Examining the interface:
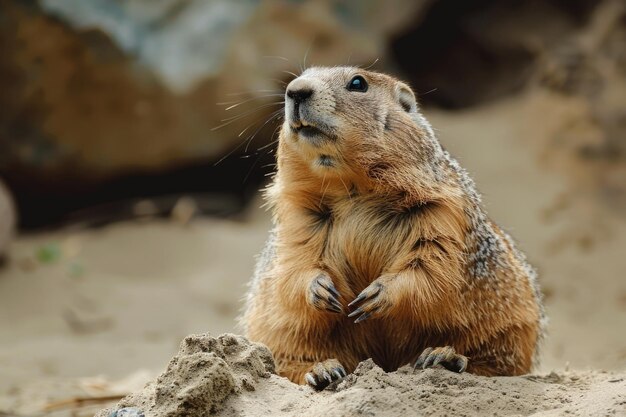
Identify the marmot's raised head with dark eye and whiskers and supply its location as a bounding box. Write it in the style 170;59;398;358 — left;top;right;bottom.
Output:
280;67;441;187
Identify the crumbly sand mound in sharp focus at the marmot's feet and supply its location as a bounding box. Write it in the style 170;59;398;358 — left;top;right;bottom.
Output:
96;334;626;417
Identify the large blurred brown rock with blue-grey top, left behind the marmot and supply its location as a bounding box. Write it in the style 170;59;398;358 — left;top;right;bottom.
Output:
0;0;430;182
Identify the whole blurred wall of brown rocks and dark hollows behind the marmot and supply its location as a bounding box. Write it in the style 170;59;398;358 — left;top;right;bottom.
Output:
0;0;626;226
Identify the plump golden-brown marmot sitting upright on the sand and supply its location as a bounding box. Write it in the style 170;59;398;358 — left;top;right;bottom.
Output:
242;67;545;389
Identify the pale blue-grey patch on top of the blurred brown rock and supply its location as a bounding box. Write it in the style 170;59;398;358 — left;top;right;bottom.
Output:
41;0;258;92
